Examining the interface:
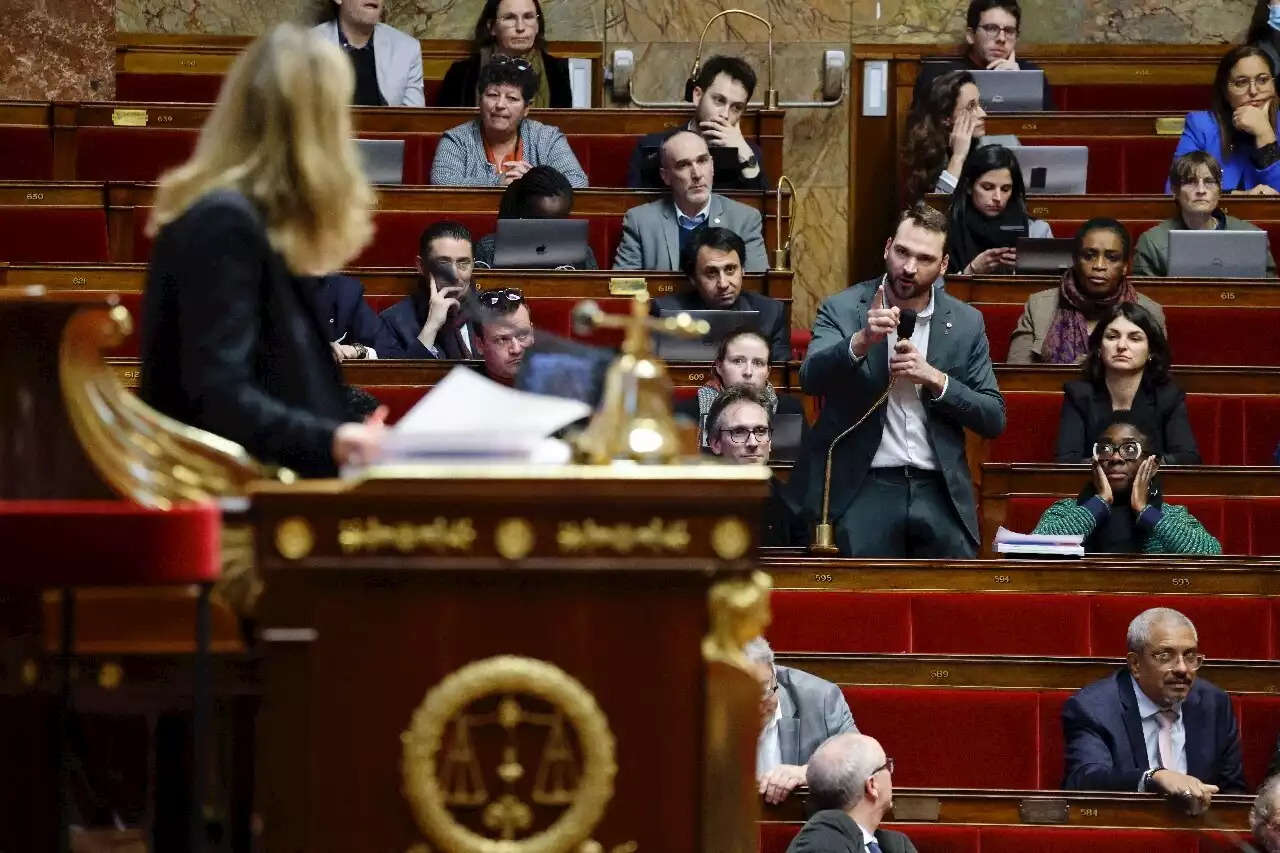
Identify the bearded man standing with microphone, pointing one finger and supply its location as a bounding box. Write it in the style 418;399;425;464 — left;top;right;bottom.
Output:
795;202;1005;558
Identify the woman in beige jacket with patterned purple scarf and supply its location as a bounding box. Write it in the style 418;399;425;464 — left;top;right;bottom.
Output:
1009;216;1165;364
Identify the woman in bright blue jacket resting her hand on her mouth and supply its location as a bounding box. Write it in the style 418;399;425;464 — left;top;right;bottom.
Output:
1165;45;1280;196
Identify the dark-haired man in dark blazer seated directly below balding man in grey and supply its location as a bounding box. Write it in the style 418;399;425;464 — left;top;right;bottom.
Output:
650;228;791;362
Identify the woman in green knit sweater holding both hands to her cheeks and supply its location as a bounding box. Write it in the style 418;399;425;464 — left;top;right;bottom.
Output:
1034;411;1222;555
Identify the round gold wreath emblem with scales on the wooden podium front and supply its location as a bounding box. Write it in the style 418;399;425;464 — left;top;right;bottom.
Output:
401;656;616;853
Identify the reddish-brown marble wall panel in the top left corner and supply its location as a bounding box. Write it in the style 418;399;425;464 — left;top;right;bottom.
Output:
0;0;115;101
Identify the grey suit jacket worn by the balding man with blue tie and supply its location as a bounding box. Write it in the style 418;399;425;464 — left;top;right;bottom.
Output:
613;193;768;273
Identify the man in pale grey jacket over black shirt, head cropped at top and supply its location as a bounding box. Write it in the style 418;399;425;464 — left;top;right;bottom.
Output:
312;0;426;106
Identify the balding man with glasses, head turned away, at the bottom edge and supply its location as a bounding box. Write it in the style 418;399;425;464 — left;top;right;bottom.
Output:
787;731;915;853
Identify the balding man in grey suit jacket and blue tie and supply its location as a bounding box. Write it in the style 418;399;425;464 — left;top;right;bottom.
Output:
613;131;768;273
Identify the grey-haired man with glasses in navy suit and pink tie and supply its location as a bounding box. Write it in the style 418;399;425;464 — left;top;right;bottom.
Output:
1062;607;1245;813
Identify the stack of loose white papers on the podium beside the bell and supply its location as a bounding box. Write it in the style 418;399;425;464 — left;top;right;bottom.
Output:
381;366;591;461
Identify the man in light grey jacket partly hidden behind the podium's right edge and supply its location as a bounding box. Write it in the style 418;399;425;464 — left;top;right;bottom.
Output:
745;637;858;804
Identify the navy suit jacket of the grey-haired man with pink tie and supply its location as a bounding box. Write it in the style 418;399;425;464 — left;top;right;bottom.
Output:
1062;670;1245;794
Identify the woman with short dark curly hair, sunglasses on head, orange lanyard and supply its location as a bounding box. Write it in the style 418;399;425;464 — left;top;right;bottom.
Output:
431;56;586;187
